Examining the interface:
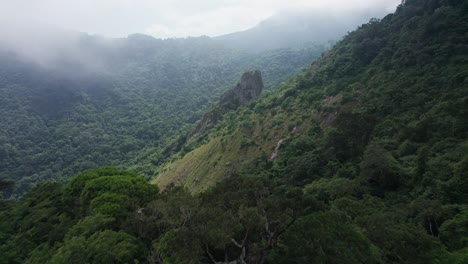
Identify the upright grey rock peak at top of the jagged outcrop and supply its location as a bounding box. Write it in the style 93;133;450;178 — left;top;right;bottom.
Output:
219;71;264;111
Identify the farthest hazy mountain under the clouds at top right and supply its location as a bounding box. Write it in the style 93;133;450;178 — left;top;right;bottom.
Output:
214;8;392;52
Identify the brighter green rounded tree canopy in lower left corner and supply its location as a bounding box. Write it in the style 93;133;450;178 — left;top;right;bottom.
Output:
0;167;158;263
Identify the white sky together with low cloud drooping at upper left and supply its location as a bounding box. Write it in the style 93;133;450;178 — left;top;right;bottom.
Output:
0;0;401;71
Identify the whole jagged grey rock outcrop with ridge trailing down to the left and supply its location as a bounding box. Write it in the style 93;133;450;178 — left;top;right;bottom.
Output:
189;70;264;136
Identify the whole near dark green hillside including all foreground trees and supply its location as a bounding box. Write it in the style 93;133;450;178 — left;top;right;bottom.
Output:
0;0;468;264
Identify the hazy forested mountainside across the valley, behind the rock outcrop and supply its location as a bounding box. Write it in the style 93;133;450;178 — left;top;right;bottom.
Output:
0;35;325;194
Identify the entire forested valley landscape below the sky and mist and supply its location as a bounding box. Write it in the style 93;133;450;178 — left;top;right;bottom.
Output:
0;0;468;264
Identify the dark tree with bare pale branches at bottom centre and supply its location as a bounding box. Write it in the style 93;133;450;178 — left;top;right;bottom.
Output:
154;176;320;263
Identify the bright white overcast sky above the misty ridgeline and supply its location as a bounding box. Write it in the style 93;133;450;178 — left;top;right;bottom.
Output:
0;0;401;38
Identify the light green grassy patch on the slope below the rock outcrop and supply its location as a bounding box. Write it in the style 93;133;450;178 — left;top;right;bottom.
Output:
157;79;318;192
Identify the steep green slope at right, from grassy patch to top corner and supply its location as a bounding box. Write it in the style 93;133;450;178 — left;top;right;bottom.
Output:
156;1;468;196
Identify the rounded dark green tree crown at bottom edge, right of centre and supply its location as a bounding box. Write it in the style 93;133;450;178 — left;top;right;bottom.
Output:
270;212;381;264
